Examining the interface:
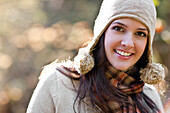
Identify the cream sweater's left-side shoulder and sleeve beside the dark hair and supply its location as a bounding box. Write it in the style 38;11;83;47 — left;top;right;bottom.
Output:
27;62;79;113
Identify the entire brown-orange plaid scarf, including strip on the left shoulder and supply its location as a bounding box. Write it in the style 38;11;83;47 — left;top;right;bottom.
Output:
57;64;157;113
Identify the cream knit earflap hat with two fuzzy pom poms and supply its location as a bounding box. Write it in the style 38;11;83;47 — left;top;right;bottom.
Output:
74;0;165;84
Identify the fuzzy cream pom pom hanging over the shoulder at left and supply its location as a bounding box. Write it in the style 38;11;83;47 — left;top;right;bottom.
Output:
74;48;94;74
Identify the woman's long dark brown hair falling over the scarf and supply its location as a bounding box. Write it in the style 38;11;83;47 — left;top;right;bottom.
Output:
74;35;159;113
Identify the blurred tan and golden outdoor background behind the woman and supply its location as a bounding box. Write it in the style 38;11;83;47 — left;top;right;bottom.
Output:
0;0;170;113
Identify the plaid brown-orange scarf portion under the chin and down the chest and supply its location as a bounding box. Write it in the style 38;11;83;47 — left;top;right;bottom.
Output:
105;65;144;113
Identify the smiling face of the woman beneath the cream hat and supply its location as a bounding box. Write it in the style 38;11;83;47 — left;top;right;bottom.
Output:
104;18;149;71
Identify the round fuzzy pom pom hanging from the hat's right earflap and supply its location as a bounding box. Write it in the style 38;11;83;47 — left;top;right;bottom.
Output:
140;63;165;84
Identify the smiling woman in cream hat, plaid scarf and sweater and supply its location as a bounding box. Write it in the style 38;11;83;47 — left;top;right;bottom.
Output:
27;0;164;113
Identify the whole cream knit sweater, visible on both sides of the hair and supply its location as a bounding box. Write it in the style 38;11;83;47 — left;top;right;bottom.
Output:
26;64;163;113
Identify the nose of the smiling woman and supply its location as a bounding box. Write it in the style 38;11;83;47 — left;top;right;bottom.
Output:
121;33;134;48
